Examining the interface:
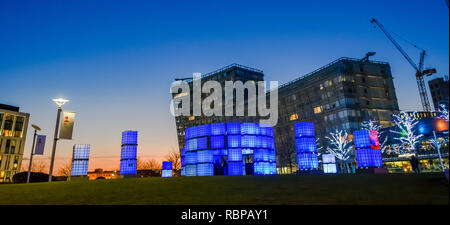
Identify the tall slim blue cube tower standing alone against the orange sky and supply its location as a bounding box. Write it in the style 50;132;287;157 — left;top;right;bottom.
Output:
120;130;138;174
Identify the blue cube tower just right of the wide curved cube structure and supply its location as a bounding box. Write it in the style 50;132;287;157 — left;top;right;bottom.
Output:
294;122;319;170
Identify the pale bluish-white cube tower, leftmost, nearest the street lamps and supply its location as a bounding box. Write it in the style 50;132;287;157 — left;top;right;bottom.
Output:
70;144;91;176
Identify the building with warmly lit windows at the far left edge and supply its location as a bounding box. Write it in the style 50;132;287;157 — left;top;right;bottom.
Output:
0;104;30;182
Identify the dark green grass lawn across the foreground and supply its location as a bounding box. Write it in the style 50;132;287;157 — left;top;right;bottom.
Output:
0;174;449;205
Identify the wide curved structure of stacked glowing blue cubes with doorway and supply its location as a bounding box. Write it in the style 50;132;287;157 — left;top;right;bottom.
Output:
182;122;276;176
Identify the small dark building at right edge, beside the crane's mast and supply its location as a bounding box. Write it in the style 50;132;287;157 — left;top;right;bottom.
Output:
428;77;449;111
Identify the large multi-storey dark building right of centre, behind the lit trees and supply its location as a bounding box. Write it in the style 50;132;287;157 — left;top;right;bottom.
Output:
274;58;399;172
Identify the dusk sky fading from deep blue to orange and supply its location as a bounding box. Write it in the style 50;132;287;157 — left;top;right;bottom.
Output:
0;0;449;169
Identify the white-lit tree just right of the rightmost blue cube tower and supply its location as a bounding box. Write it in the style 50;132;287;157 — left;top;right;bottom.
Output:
391;112;423;154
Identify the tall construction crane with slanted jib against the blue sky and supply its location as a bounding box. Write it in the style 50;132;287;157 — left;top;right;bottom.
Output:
370;19;436;112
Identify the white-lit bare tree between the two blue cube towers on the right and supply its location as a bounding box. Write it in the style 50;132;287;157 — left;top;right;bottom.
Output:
325;129;353;173
